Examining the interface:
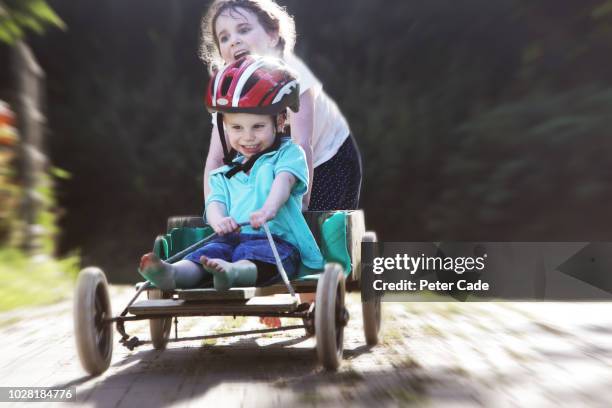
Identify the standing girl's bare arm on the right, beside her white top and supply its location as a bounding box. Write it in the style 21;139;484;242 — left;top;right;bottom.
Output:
288;88;314;210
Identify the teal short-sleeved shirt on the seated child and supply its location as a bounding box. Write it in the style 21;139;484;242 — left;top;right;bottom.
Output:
206;138;324;269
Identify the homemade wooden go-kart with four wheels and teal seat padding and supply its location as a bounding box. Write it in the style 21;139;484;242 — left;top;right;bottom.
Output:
74;210;381;375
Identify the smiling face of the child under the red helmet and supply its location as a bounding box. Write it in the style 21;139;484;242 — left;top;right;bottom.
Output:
223;113;276;159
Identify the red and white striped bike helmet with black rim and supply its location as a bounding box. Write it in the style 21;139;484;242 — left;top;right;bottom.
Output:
206;55;300;115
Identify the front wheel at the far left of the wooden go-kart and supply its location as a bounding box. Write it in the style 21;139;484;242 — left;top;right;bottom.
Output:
74;267;113;375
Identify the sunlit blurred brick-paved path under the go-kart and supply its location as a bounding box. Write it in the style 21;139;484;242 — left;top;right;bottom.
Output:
0;287;612;408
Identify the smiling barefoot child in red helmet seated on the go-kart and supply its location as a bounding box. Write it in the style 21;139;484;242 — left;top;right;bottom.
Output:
139;56;323;290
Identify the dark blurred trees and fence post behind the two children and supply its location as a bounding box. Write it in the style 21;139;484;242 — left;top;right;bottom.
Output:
0;0;612;283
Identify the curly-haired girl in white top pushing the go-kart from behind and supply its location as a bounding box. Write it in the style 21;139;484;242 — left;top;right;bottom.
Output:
201;0;361;211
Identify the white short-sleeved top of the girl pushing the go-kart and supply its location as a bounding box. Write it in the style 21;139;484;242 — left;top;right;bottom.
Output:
212;53;350;167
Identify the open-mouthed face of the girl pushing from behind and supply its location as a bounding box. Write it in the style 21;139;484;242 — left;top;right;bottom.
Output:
215;7;278;64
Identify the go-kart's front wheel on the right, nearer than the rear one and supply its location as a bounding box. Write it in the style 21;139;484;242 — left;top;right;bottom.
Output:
315;263;348;370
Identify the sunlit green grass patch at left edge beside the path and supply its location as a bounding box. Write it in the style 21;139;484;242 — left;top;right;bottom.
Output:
0;248;79;312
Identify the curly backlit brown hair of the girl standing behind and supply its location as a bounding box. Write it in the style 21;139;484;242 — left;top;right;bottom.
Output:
200;0;295;70
